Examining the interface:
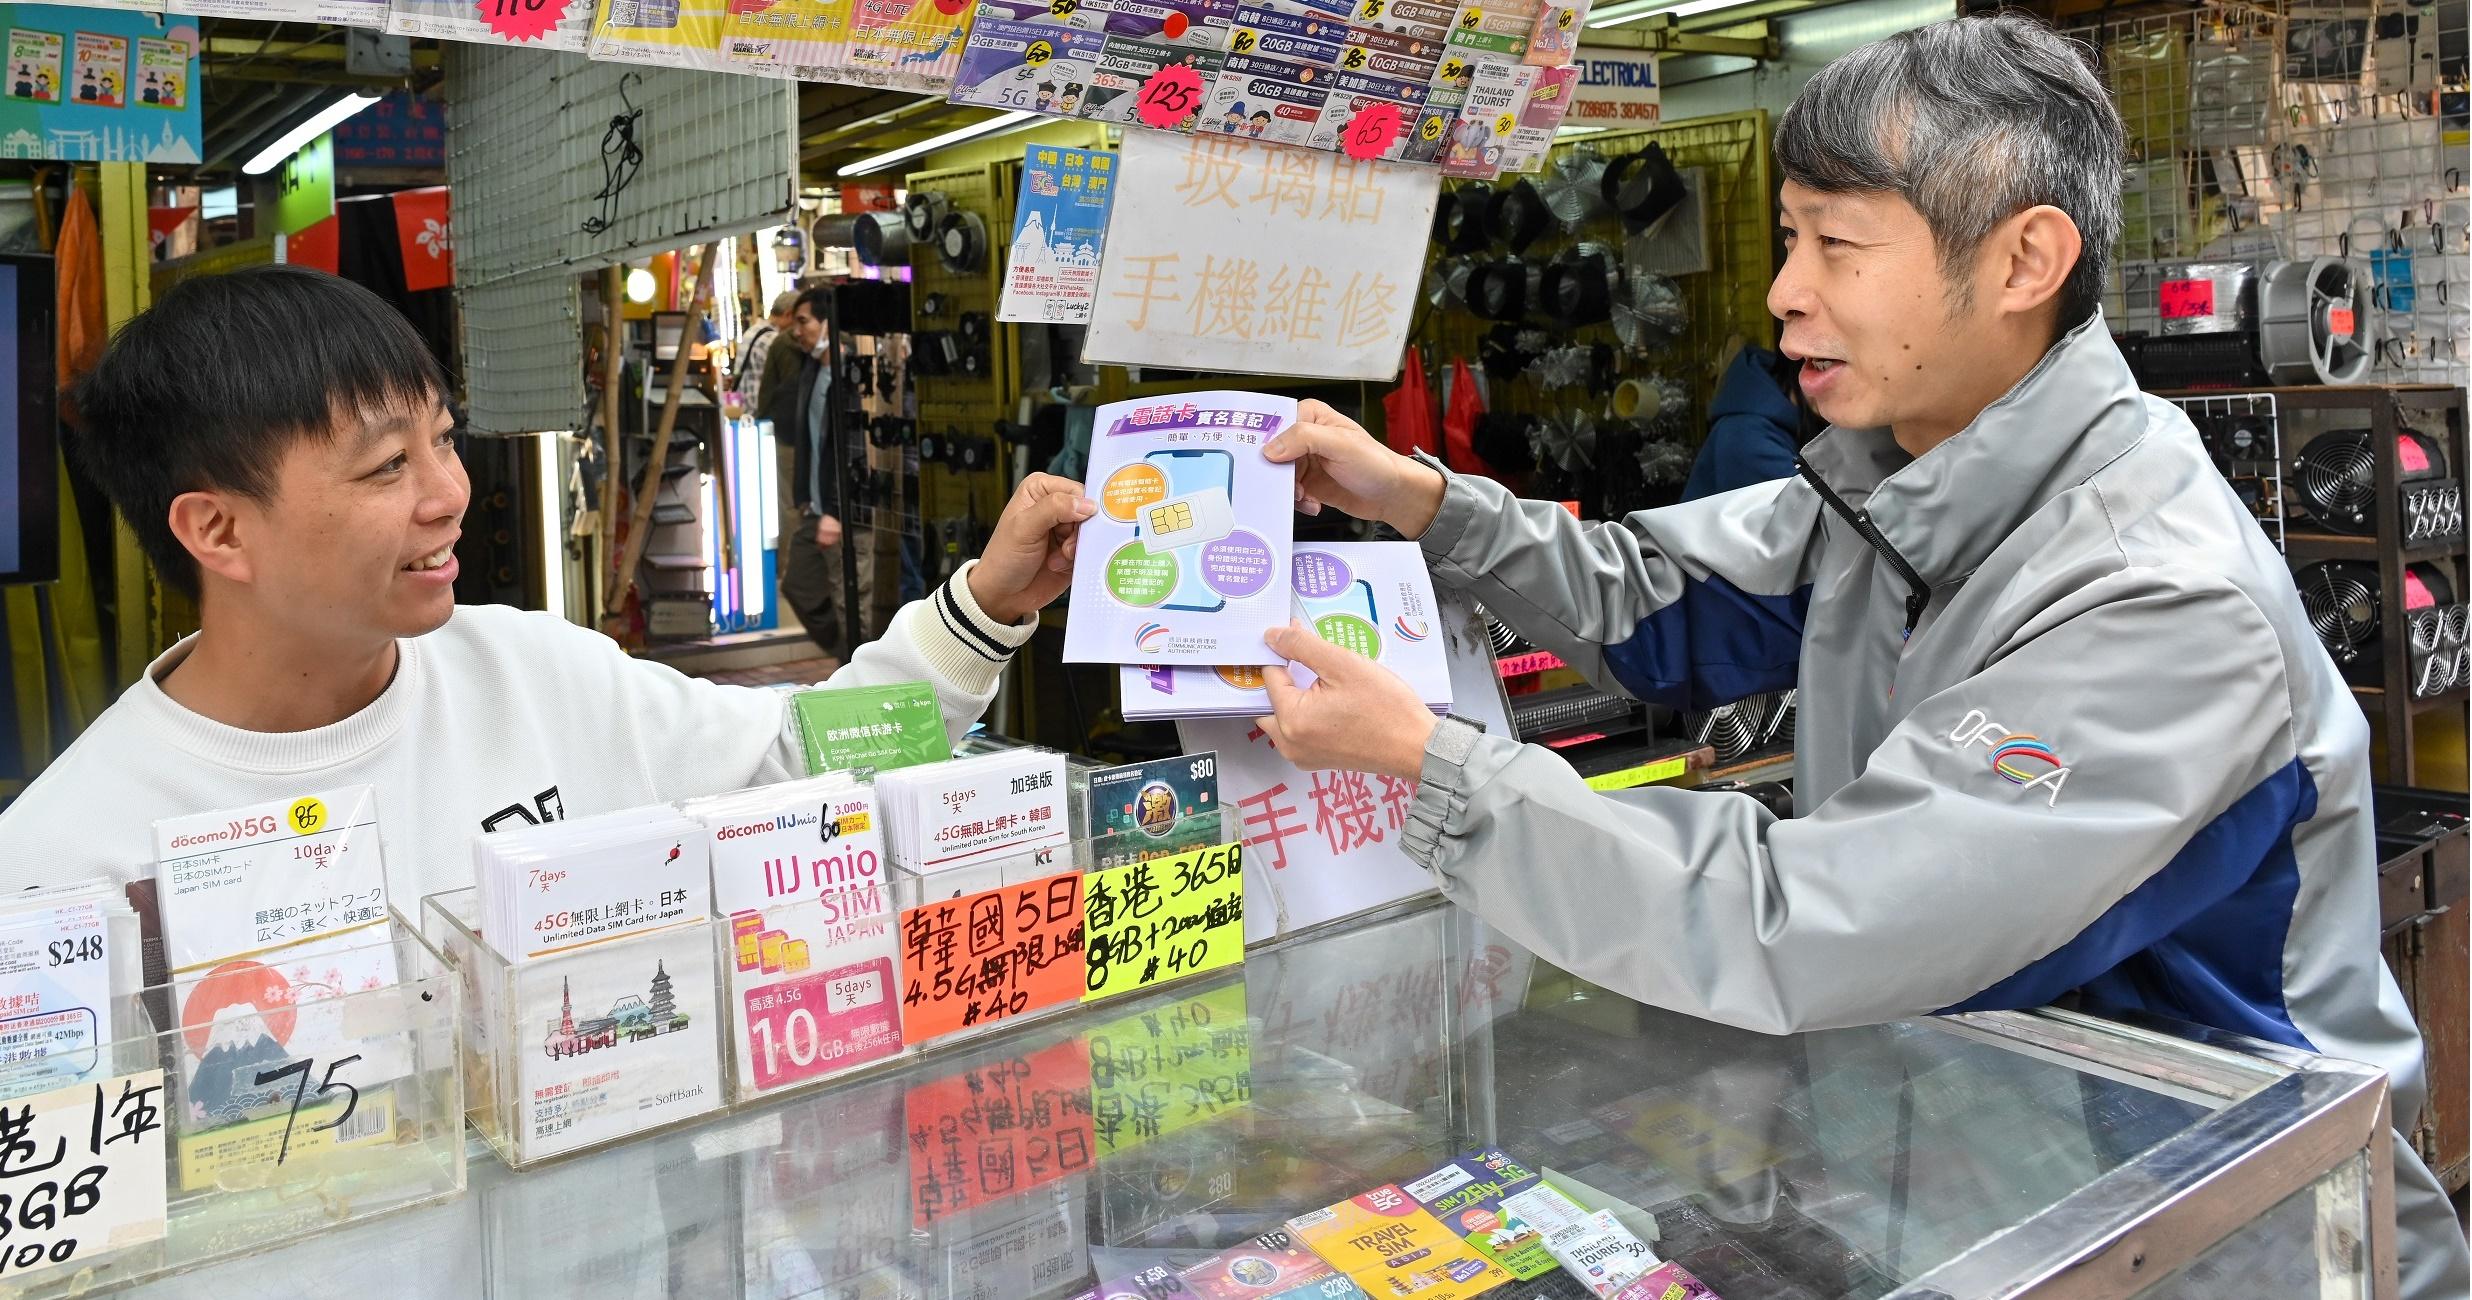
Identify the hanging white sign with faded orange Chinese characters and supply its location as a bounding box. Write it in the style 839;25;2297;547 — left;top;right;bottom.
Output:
1083;131;1441;381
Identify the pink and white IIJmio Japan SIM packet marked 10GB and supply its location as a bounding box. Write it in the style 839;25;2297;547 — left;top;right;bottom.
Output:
680;774;902;1092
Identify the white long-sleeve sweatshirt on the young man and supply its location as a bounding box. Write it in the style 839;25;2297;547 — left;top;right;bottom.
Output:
0;568;1036;919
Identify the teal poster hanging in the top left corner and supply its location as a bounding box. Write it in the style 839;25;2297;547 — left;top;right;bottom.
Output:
0;5;200;163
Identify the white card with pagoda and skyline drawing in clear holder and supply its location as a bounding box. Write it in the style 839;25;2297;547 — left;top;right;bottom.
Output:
509;927;722;1159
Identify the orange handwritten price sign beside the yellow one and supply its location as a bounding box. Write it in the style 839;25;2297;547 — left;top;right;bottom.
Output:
900;872;1083;1043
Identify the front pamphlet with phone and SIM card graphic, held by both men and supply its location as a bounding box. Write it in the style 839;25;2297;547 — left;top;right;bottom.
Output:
1065;393;1295;665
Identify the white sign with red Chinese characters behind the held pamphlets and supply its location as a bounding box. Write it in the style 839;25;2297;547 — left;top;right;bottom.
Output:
1177;591;1513;944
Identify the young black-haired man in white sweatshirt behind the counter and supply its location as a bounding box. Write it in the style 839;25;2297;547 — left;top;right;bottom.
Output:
0;267;1093;914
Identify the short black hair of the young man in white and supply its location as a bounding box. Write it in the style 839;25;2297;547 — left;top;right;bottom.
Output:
69;267;452;596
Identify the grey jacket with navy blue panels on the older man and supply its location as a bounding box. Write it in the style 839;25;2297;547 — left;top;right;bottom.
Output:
1409;316;2467;1300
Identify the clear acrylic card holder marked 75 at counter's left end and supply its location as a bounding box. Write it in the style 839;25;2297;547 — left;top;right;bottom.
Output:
0;917;465;1300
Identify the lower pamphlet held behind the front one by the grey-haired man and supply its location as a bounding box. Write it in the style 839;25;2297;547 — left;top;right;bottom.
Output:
1120;541;1451;722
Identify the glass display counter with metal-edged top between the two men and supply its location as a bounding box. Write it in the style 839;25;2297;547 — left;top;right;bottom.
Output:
131;902;2393;1300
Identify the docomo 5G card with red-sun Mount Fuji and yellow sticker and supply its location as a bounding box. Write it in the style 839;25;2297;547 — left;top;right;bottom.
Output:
153;786;410;1166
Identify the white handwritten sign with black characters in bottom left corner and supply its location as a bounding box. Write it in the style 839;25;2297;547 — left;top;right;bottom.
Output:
0;1070;166;1288
